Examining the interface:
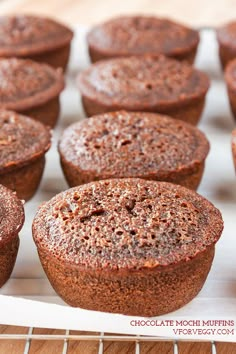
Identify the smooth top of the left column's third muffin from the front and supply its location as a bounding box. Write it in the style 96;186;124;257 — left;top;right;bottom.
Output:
0;58;64;111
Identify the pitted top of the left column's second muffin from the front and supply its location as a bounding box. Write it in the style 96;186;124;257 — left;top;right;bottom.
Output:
0;110;51;174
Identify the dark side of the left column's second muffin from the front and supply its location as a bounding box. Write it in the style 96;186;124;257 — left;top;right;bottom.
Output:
0;155;45;201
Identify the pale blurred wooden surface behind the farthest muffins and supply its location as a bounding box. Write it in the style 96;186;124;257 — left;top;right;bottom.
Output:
0;0;236;26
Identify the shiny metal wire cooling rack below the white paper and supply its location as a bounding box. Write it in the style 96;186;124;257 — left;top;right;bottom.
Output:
0;327;217;354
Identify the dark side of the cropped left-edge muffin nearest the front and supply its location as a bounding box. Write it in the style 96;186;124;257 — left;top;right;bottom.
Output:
0;235;20;288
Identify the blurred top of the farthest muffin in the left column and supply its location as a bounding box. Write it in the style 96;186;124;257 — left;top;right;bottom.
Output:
0;15;73;57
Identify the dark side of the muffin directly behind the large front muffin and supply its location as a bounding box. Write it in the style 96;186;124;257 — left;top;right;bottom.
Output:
60;156;205;190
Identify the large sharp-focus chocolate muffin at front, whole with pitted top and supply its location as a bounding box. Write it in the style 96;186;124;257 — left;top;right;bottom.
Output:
33;178;223;316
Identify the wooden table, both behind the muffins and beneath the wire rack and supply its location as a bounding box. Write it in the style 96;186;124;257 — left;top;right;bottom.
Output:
0;0;236;354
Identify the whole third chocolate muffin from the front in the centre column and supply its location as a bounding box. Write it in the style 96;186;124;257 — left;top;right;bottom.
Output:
78;56;209;124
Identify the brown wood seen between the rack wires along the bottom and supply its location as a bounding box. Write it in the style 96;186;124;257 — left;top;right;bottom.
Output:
0;325;236;354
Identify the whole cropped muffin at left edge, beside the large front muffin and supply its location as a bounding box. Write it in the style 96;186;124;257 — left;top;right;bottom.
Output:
0;185;25;287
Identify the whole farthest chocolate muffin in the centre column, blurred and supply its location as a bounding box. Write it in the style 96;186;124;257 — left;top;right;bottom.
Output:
87;16;199;63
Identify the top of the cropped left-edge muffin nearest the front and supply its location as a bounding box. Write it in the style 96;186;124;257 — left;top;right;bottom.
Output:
0;184;25;246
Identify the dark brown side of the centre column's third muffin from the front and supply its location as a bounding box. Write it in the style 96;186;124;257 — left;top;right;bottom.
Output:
82;96;205;125
